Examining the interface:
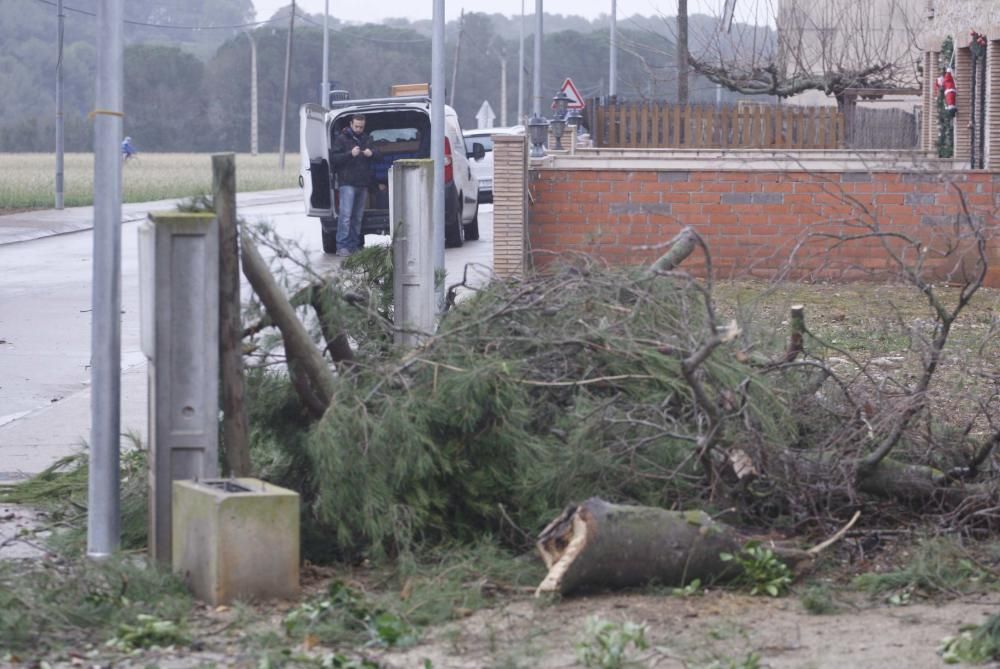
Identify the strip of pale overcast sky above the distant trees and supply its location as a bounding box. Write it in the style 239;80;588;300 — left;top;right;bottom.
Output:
254;0;770;29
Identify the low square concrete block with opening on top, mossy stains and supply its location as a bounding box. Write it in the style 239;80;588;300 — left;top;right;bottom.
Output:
171;478;299;606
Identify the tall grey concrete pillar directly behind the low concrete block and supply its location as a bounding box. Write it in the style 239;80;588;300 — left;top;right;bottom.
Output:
139;212;219;562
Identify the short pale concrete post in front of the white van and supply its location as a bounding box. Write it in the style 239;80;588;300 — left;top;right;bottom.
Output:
389;160;437;347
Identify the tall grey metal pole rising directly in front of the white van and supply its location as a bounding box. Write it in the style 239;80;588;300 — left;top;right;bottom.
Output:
431;0;446;310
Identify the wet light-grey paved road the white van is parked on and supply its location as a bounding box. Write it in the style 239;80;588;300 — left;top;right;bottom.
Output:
0;189;493;481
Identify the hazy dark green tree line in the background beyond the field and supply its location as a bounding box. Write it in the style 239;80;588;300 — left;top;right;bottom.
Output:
0;0;736;152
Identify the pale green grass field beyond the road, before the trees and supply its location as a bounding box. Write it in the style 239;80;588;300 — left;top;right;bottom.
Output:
0;153;299;211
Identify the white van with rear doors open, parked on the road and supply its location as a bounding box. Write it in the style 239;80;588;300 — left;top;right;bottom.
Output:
299;95;485;253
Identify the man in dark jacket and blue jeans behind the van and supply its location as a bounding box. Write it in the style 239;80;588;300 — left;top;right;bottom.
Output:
331;114;375;256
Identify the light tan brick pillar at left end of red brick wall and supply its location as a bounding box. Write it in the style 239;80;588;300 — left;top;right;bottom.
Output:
493;135;528;278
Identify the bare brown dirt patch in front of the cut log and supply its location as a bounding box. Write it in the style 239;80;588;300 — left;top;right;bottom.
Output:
381;592;1000;669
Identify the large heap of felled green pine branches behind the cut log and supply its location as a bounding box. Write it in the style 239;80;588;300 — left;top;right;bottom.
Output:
292;260;792;556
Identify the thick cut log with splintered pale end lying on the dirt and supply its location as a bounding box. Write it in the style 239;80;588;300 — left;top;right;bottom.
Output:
535;497;743;595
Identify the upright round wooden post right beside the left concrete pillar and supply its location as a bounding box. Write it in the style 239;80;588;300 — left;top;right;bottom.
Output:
212;153;251;476
